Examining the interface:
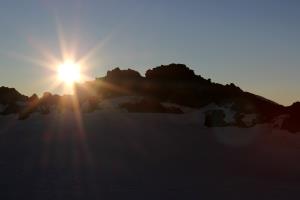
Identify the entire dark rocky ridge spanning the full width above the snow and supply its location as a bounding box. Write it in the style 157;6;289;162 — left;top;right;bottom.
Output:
0;63;300;132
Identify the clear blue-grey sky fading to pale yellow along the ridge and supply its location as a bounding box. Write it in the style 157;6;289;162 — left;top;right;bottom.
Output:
0;0;300;105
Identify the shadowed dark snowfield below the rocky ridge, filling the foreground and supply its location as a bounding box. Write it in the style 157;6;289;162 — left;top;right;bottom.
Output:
0;97;300;200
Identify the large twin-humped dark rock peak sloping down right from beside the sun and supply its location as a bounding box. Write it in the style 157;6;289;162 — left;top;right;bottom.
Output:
86;63;284;118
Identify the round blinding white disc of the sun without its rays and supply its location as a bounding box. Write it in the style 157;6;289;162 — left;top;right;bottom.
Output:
57;60;81;85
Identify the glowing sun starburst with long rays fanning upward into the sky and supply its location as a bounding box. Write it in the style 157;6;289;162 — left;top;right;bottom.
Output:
10;12;117;97
